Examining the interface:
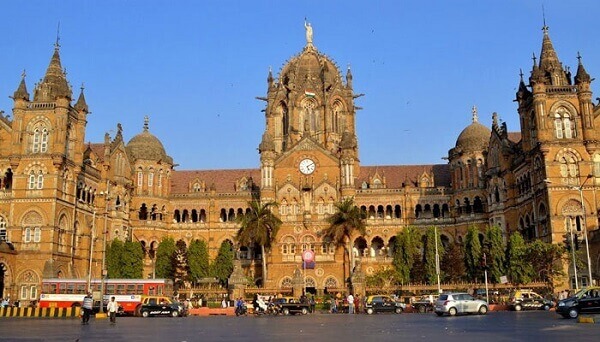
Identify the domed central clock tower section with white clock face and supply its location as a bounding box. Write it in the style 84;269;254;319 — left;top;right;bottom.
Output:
259;26;359;286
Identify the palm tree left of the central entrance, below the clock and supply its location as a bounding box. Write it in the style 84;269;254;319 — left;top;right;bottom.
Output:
236;200;281;287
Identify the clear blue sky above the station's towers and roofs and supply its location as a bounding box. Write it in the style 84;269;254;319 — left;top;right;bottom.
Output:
0;0;600;170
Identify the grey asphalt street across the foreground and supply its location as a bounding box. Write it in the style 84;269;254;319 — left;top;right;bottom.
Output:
0;311;600;342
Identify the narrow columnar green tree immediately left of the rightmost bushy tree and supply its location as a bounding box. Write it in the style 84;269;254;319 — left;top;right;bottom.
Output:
506;232;533;285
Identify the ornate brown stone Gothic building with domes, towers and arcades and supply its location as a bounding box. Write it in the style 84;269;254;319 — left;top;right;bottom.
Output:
0;27;600;301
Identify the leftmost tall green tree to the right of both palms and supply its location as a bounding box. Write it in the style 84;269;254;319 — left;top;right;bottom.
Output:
392;227;421;283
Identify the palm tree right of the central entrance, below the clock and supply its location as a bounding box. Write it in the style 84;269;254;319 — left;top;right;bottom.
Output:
322;197;367;288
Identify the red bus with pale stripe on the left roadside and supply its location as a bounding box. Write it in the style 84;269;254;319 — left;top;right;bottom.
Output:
39;278;173;315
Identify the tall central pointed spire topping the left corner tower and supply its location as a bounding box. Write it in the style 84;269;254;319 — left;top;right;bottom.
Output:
34;43;73;102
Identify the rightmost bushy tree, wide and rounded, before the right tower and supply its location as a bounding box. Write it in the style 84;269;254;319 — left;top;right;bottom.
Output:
526;240;566;284
